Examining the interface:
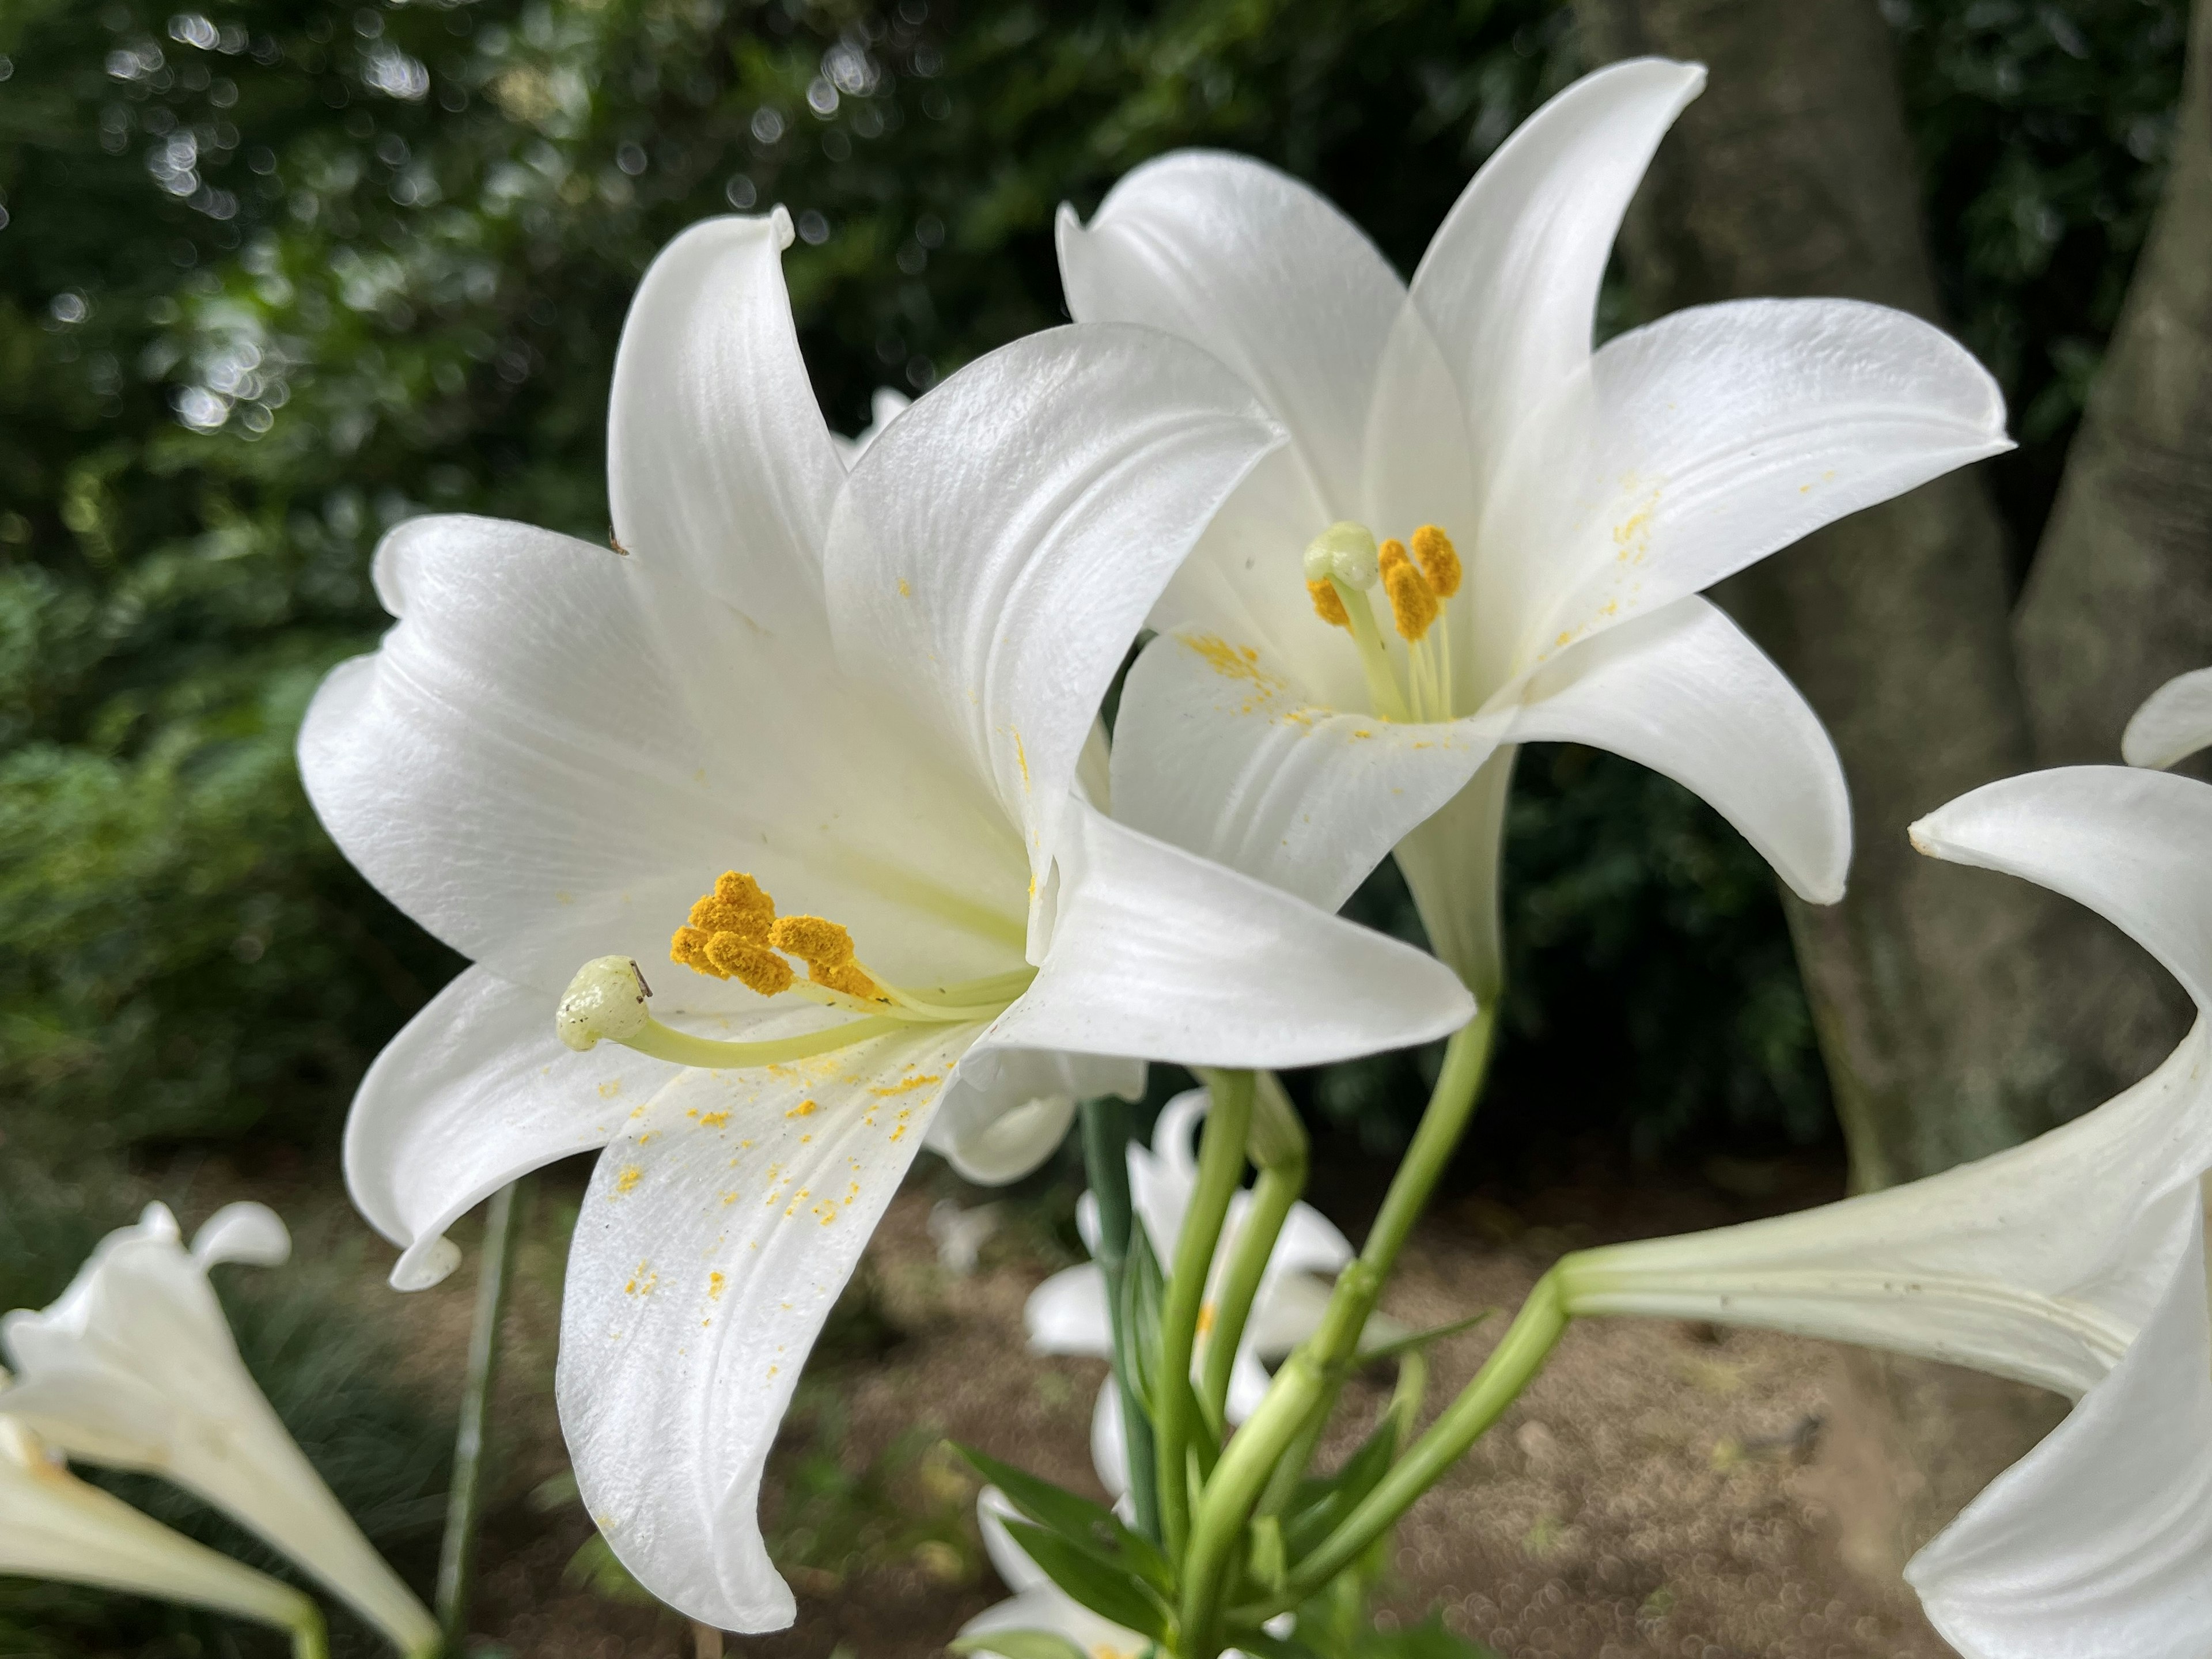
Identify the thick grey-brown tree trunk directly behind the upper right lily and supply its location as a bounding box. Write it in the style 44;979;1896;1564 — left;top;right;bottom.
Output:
1577;0;2179;1584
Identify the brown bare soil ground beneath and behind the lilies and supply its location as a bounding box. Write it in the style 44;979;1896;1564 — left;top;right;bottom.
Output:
188;1166;1949;1659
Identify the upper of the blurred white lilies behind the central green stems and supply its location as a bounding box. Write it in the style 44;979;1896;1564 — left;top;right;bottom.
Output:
1022;1088;1351;1442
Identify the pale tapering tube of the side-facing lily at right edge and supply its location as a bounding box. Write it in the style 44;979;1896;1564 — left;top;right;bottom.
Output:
1569;1026;2212;1396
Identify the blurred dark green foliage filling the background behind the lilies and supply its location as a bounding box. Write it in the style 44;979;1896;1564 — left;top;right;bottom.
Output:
0;0;2179;1157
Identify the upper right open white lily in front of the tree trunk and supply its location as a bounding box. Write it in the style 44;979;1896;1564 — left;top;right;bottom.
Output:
1059;60;2009;995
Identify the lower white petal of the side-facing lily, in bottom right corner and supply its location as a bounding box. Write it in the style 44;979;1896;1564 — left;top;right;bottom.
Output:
1904;1192;2212;1659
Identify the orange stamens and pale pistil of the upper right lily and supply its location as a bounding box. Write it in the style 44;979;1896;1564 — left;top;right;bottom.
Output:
1305;520;1460;724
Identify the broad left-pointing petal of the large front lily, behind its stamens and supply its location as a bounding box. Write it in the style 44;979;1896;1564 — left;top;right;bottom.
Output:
298;518;1027;1011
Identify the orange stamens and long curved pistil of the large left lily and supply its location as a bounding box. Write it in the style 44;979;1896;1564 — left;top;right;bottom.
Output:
553;869;1037;1071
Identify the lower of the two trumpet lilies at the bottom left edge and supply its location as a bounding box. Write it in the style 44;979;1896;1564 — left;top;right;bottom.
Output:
0;1415;321;1652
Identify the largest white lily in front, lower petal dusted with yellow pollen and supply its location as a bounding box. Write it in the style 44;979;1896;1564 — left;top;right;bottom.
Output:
301;210;1471;1630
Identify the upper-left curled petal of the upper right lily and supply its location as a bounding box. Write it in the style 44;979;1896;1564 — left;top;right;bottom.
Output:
1055;150;1404;533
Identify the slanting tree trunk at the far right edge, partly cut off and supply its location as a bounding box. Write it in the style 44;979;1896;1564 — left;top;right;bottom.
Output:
2015;0;2212;766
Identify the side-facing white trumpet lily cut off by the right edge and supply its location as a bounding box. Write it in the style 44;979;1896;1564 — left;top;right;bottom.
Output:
1562;767;2212;1659
